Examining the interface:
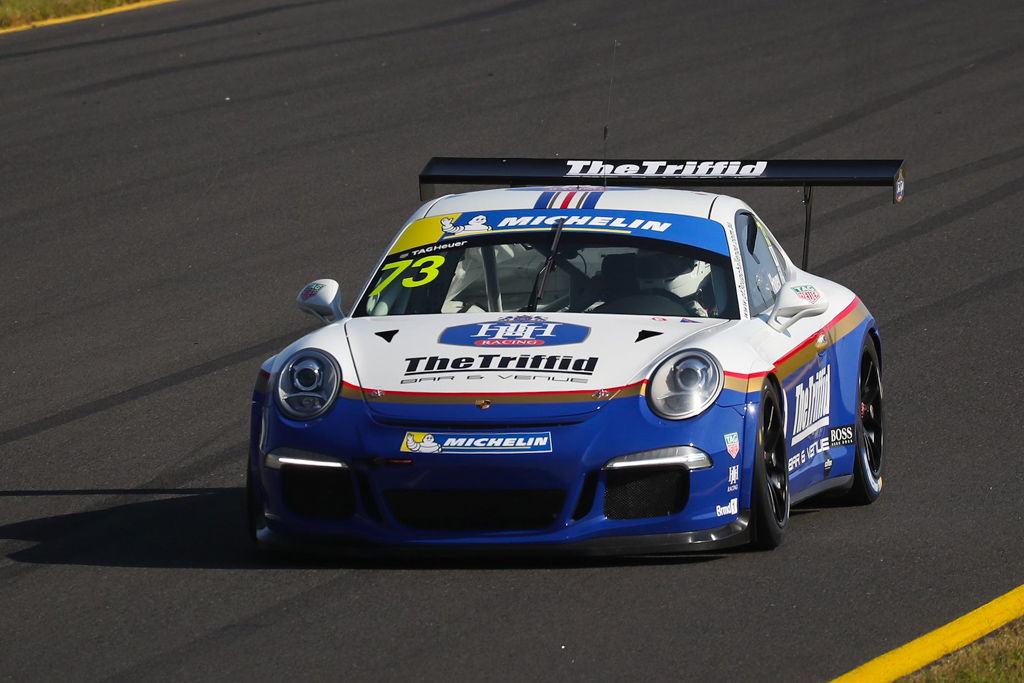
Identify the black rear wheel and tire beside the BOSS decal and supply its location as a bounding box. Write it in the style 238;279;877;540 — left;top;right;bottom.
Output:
847;337;885;505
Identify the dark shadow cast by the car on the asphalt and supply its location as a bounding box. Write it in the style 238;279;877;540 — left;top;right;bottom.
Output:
0;487;730;570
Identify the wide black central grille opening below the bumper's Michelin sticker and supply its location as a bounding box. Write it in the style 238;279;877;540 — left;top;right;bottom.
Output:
384;488;565;531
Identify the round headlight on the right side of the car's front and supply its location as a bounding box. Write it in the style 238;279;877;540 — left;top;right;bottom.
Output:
647;349;723;420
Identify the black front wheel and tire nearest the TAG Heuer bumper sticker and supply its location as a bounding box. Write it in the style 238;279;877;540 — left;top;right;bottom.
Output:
751;380;790;550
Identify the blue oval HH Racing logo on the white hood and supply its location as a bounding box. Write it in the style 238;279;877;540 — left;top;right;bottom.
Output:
437;315;590;346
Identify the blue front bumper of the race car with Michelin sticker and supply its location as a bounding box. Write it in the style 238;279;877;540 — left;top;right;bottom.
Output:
250;387;756;555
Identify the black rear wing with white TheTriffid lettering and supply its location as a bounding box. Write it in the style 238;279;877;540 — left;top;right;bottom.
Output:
420;157;905;268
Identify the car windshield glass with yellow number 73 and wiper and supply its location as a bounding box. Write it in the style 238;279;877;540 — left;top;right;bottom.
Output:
355;230;739;318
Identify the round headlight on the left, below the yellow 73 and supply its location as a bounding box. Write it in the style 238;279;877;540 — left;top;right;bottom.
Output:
278;348;341;420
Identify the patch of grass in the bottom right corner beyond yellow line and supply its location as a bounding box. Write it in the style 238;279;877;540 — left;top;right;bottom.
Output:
900;618;1024;683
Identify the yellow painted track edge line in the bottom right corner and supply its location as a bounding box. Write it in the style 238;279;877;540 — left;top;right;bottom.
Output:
833;586;1024;683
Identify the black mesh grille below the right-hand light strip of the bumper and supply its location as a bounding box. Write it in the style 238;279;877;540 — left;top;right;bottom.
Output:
604;468;690;519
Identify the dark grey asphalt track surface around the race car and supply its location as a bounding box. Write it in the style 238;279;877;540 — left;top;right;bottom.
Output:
0;0;1024;681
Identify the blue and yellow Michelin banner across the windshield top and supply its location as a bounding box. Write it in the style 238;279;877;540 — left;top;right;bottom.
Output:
389;209;729;256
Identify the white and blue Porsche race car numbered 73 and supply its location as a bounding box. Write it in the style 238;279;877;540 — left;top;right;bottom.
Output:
247;158;903;554
